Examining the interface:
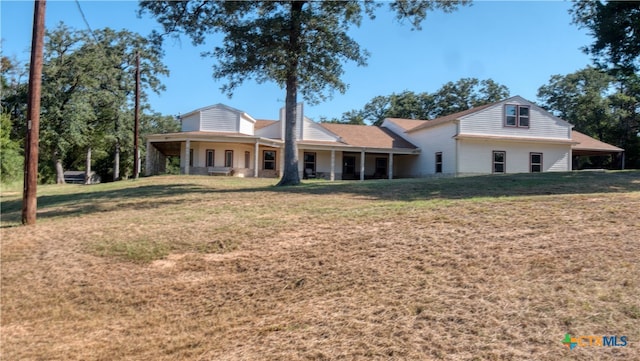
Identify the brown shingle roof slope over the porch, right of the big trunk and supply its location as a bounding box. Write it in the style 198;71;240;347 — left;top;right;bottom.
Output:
320;123;417;149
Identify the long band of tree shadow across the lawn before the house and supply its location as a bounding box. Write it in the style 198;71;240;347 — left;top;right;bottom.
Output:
2;171;640;227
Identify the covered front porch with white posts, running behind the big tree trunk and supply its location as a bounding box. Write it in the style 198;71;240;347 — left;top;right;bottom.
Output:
145;132;420;181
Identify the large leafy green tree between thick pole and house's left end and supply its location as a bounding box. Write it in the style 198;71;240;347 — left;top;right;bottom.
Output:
41;24;168;182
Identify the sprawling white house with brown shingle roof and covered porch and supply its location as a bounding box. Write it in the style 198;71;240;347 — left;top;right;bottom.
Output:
145;96;623;180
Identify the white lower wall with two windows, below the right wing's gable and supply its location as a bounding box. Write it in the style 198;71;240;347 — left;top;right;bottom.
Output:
458;139;571;176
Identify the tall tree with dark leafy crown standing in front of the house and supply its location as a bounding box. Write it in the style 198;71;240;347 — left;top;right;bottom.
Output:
140;0;468;185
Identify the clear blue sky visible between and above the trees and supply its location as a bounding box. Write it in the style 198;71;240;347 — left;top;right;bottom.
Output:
0;0;592;119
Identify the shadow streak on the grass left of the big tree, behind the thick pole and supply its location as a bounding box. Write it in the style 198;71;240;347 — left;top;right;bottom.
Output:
2;184;210;228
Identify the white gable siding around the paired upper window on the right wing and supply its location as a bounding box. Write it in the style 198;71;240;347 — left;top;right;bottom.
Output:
460;97;571;139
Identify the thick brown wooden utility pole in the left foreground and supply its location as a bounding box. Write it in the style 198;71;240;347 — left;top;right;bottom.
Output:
22;0;46;225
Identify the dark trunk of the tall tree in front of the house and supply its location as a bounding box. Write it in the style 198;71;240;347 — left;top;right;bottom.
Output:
277;1;305;186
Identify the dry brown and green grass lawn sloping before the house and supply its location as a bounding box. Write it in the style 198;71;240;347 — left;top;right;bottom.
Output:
0;172;640;360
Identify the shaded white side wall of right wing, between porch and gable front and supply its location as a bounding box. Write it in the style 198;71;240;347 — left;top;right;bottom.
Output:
398;122;457;177
